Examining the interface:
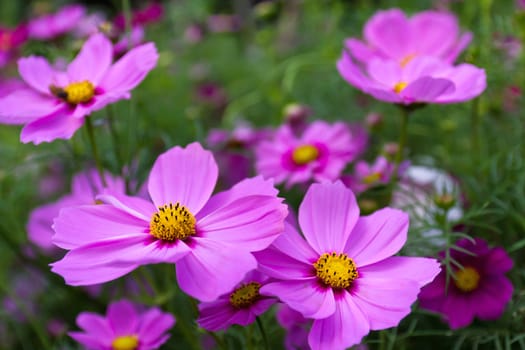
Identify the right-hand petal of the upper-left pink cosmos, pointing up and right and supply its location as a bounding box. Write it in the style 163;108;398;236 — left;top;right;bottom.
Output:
100;43;159;94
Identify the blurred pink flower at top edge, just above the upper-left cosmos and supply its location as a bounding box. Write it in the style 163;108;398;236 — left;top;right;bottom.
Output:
28;4;86;40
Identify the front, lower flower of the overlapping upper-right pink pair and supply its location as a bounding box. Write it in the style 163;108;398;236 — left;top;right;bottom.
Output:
337;52;487;105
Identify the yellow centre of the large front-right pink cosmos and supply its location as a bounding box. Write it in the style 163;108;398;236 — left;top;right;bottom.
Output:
314;253;359;289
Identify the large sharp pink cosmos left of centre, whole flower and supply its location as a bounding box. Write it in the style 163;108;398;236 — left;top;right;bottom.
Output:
52;143;287;301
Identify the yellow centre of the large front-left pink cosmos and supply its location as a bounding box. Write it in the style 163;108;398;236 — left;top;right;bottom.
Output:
149;202;196;242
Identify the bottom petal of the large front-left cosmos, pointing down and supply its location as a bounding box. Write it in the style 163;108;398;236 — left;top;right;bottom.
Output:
176;238;257;301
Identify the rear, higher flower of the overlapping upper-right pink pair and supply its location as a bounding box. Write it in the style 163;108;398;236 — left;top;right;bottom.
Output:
345;9;472;66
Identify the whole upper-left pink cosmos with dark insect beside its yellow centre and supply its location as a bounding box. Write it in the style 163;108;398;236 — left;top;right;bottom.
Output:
0;33;158;144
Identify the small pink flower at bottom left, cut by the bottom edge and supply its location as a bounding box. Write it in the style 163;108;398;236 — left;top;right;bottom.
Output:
68;300;175;350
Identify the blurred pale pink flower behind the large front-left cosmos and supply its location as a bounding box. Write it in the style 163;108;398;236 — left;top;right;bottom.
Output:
27;170;126;253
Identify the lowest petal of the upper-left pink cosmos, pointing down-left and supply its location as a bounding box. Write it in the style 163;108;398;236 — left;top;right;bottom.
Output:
20;109;84;145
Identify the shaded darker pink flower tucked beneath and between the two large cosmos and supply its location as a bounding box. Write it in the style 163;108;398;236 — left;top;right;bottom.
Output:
197;270;277;332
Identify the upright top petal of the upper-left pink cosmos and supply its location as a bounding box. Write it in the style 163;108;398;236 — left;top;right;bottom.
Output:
67;33;113;87
